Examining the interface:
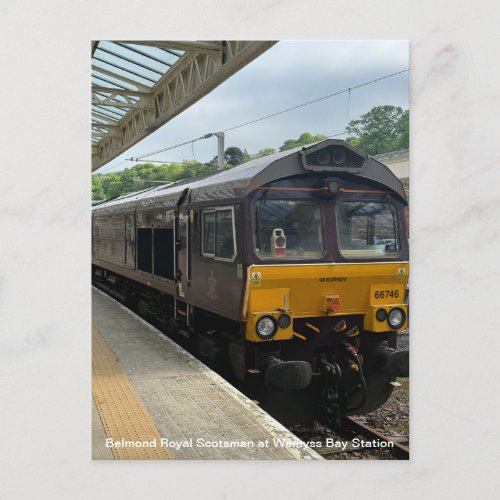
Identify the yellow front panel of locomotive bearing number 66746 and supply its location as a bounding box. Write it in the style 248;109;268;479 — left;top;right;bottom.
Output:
243;262;408;342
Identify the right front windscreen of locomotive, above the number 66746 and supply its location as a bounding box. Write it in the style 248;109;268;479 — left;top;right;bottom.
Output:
337;201;400;259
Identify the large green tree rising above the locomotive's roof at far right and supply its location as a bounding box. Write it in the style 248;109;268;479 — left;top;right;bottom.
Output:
346;105;409;155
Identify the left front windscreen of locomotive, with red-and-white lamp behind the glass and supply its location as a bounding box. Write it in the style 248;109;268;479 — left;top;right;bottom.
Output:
254;200;324;259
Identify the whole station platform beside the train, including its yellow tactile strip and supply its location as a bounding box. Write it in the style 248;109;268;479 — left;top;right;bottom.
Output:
92;288;322;460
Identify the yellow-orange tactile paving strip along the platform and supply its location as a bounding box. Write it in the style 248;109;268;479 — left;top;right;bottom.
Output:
92;328;174;460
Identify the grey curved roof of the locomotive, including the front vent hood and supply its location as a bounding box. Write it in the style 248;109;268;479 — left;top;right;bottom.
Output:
93;139;406;215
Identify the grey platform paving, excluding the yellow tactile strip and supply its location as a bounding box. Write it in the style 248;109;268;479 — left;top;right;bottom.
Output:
92;288;322;460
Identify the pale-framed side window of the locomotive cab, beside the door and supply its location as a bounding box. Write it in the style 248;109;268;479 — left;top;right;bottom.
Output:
202;208;236;260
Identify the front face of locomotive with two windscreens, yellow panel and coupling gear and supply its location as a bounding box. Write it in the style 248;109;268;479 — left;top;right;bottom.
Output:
239;143;409;423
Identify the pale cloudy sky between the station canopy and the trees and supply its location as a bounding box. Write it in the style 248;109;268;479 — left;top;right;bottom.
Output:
96;40;409;173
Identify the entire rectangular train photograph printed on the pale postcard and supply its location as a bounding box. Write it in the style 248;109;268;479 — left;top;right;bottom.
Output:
91;40;410;460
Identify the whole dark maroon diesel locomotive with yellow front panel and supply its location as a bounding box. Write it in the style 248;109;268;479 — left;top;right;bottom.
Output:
92;139;409;426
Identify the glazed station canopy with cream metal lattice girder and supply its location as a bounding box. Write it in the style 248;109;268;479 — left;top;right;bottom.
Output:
92;40;276;171
